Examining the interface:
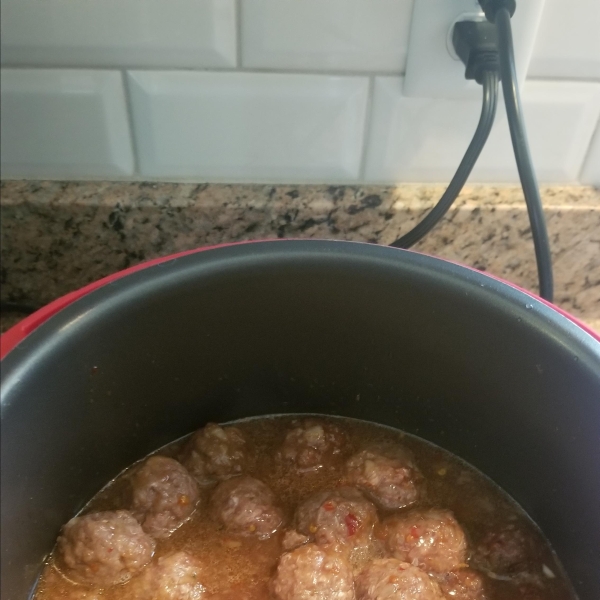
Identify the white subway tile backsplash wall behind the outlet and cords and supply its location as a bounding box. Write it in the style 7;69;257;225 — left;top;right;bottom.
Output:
1;0;600;185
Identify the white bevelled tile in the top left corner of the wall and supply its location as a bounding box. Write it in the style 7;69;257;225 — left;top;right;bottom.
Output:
1;0;236;68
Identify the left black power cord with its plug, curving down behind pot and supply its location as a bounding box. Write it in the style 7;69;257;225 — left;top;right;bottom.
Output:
390;21;499;249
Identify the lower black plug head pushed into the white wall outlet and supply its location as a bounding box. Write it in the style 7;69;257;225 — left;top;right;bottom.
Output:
452;21;500;84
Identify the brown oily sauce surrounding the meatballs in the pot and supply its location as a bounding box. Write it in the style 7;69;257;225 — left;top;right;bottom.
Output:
34;416;575;600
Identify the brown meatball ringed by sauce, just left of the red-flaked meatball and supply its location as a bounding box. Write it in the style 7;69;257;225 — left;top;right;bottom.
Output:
211;476;283;539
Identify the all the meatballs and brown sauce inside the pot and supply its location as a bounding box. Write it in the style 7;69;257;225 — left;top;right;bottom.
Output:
34;417;575;600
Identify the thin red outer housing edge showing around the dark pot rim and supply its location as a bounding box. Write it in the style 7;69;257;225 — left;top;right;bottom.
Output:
0;240;600;360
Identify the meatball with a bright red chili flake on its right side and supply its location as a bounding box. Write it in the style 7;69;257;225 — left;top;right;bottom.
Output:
296;487;377;546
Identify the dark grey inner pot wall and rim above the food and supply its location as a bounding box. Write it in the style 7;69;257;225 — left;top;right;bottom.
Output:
1;241;600;600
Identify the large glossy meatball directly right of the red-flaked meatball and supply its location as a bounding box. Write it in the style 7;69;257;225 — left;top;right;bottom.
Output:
385;509;467;573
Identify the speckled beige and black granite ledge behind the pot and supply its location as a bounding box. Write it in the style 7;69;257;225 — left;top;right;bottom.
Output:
0;181;600;330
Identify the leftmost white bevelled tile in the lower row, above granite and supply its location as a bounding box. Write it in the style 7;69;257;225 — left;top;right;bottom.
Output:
1;69;134;179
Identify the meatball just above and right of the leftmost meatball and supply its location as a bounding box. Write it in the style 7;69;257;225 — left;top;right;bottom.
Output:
131;456;200;539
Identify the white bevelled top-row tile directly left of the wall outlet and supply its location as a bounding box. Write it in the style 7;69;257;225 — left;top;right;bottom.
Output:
241;0;413;73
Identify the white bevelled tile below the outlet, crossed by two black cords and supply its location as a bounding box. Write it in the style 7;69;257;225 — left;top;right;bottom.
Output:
366;77;600;183
